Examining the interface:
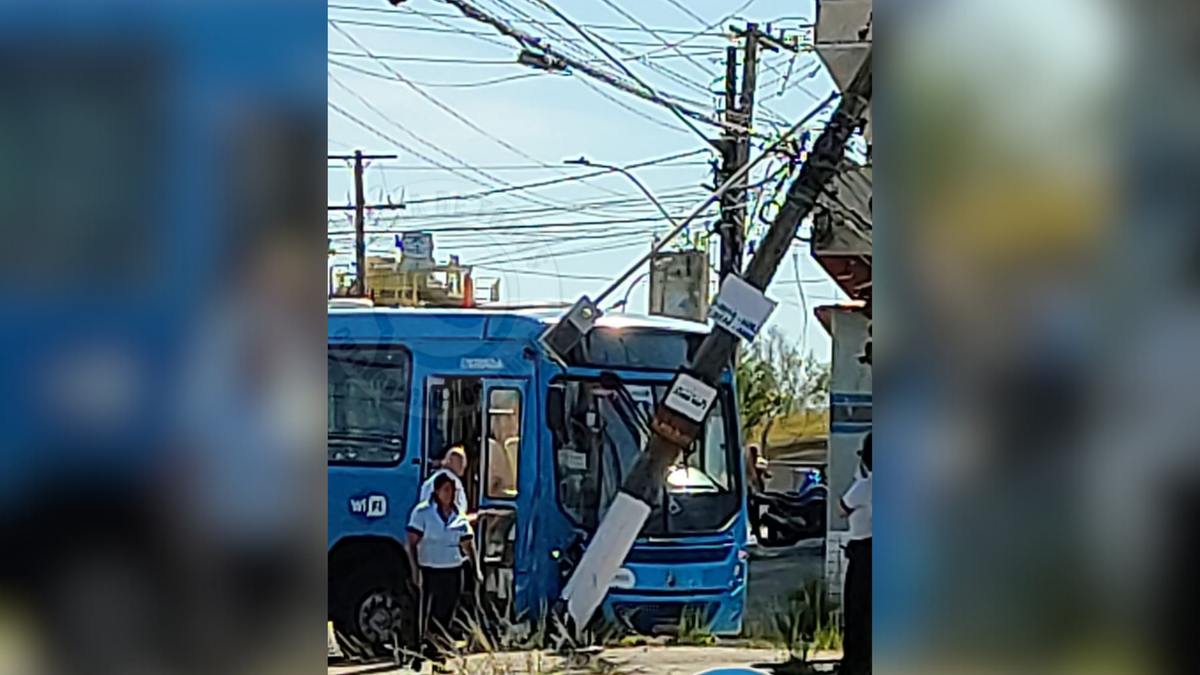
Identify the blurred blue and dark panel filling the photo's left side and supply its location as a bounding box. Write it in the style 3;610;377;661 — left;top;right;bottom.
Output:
0;1;325;675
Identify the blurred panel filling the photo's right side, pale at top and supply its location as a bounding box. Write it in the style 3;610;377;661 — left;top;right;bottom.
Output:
875;0;1200;673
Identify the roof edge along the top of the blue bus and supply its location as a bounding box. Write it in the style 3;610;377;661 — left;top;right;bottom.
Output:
329;304;710;340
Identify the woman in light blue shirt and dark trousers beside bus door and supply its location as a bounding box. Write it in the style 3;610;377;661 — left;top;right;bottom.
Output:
407;473;481;662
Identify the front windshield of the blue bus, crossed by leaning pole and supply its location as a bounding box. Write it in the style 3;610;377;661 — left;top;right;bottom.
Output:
547;374;742;536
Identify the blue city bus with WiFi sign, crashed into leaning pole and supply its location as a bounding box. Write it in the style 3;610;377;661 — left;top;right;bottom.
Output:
328;304;748;644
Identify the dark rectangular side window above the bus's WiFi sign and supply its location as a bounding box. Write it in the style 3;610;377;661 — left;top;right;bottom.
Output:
328;345;413;465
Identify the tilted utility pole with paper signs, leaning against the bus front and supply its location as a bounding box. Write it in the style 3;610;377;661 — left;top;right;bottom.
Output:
562;52;871;628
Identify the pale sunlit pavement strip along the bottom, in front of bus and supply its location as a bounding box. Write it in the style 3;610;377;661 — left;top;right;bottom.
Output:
329;646;838;675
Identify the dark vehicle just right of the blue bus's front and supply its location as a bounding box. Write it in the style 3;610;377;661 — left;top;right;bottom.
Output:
750;470;829;546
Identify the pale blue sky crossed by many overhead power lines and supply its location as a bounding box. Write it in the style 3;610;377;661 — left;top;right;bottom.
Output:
329;0;844;360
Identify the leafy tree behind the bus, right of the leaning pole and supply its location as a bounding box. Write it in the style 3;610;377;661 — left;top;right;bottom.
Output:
734;328;829;448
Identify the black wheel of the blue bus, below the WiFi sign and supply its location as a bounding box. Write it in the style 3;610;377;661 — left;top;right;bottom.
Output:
331;566;416;652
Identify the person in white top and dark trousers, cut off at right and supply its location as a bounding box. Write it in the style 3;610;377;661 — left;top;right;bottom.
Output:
839;432;871;675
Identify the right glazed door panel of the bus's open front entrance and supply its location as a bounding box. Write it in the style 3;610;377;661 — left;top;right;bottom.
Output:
475;378;534;603
